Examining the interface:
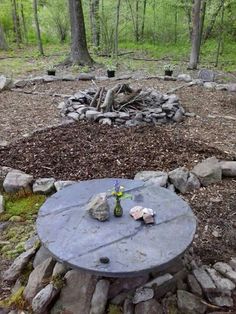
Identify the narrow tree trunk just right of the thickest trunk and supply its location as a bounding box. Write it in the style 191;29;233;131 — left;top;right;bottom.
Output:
89;0;100;47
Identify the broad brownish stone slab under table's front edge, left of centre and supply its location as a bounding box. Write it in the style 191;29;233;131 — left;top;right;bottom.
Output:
51;270;97;314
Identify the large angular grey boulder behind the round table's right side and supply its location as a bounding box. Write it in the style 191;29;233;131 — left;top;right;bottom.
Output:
192;157;222;186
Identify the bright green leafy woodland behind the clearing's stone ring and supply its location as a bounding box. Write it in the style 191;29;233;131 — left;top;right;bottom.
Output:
0;0;236;72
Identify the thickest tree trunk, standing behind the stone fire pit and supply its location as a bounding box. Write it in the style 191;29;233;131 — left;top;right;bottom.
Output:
69;0;93;65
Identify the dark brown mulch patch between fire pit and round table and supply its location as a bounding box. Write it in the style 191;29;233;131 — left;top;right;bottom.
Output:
0;123;230;180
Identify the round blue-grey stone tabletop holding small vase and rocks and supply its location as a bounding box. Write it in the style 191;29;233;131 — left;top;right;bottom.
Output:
37;179;196;277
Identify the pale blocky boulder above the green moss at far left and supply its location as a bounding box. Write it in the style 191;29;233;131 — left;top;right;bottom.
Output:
3;169;33;193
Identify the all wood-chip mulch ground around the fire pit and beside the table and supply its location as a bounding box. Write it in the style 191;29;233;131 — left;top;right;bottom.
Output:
0;63;236;304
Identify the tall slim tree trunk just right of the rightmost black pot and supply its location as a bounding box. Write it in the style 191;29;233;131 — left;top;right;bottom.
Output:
188;0;201;69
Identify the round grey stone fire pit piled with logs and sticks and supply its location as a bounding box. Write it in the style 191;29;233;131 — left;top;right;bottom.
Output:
58;84;185;126
